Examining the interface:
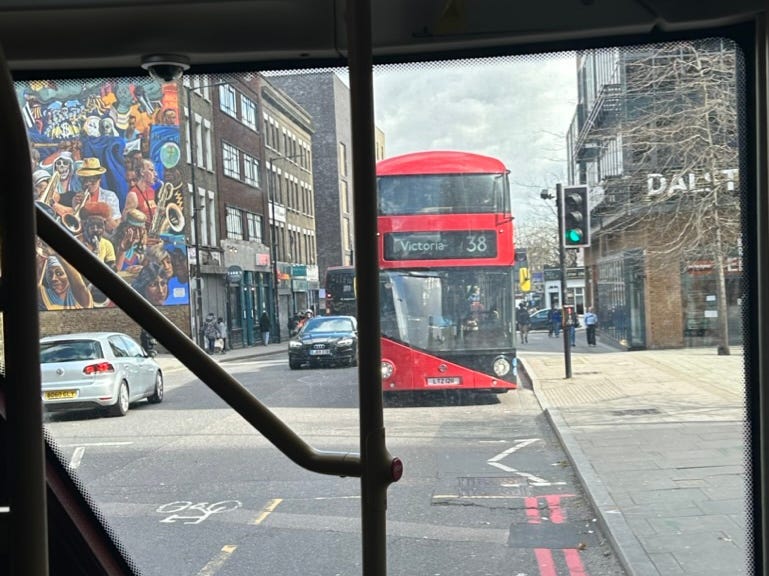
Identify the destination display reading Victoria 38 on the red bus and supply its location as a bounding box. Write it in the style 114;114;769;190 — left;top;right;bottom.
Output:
384;230;497;260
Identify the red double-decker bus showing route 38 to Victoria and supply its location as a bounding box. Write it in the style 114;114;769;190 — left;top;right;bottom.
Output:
377;151;517;392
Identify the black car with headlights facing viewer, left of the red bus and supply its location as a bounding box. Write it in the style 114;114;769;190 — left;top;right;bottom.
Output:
288;316;358;370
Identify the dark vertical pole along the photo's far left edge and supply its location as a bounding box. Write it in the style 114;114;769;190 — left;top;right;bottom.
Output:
0;42;48;576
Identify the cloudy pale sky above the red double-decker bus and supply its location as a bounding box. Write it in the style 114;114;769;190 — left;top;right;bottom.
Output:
374;54;577;218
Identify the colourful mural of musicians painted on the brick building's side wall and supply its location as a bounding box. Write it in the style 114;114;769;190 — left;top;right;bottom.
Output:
16;78;189;310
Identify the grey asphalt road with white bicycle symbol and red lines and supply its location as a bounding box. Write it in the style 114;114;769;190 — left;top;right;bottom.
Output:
47;352;622;576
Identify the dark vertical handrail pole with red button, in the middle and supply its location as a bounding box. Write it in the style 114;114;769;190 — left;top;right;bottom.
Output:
347;0;400;576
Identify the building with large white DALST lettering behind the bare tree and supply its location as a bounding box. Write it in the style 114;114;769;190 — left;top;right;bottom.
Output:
567;41;742;351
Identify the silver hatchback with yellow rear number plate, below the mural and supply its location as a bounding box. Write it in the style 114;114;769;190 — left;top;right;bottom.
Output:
40;332;163;416
